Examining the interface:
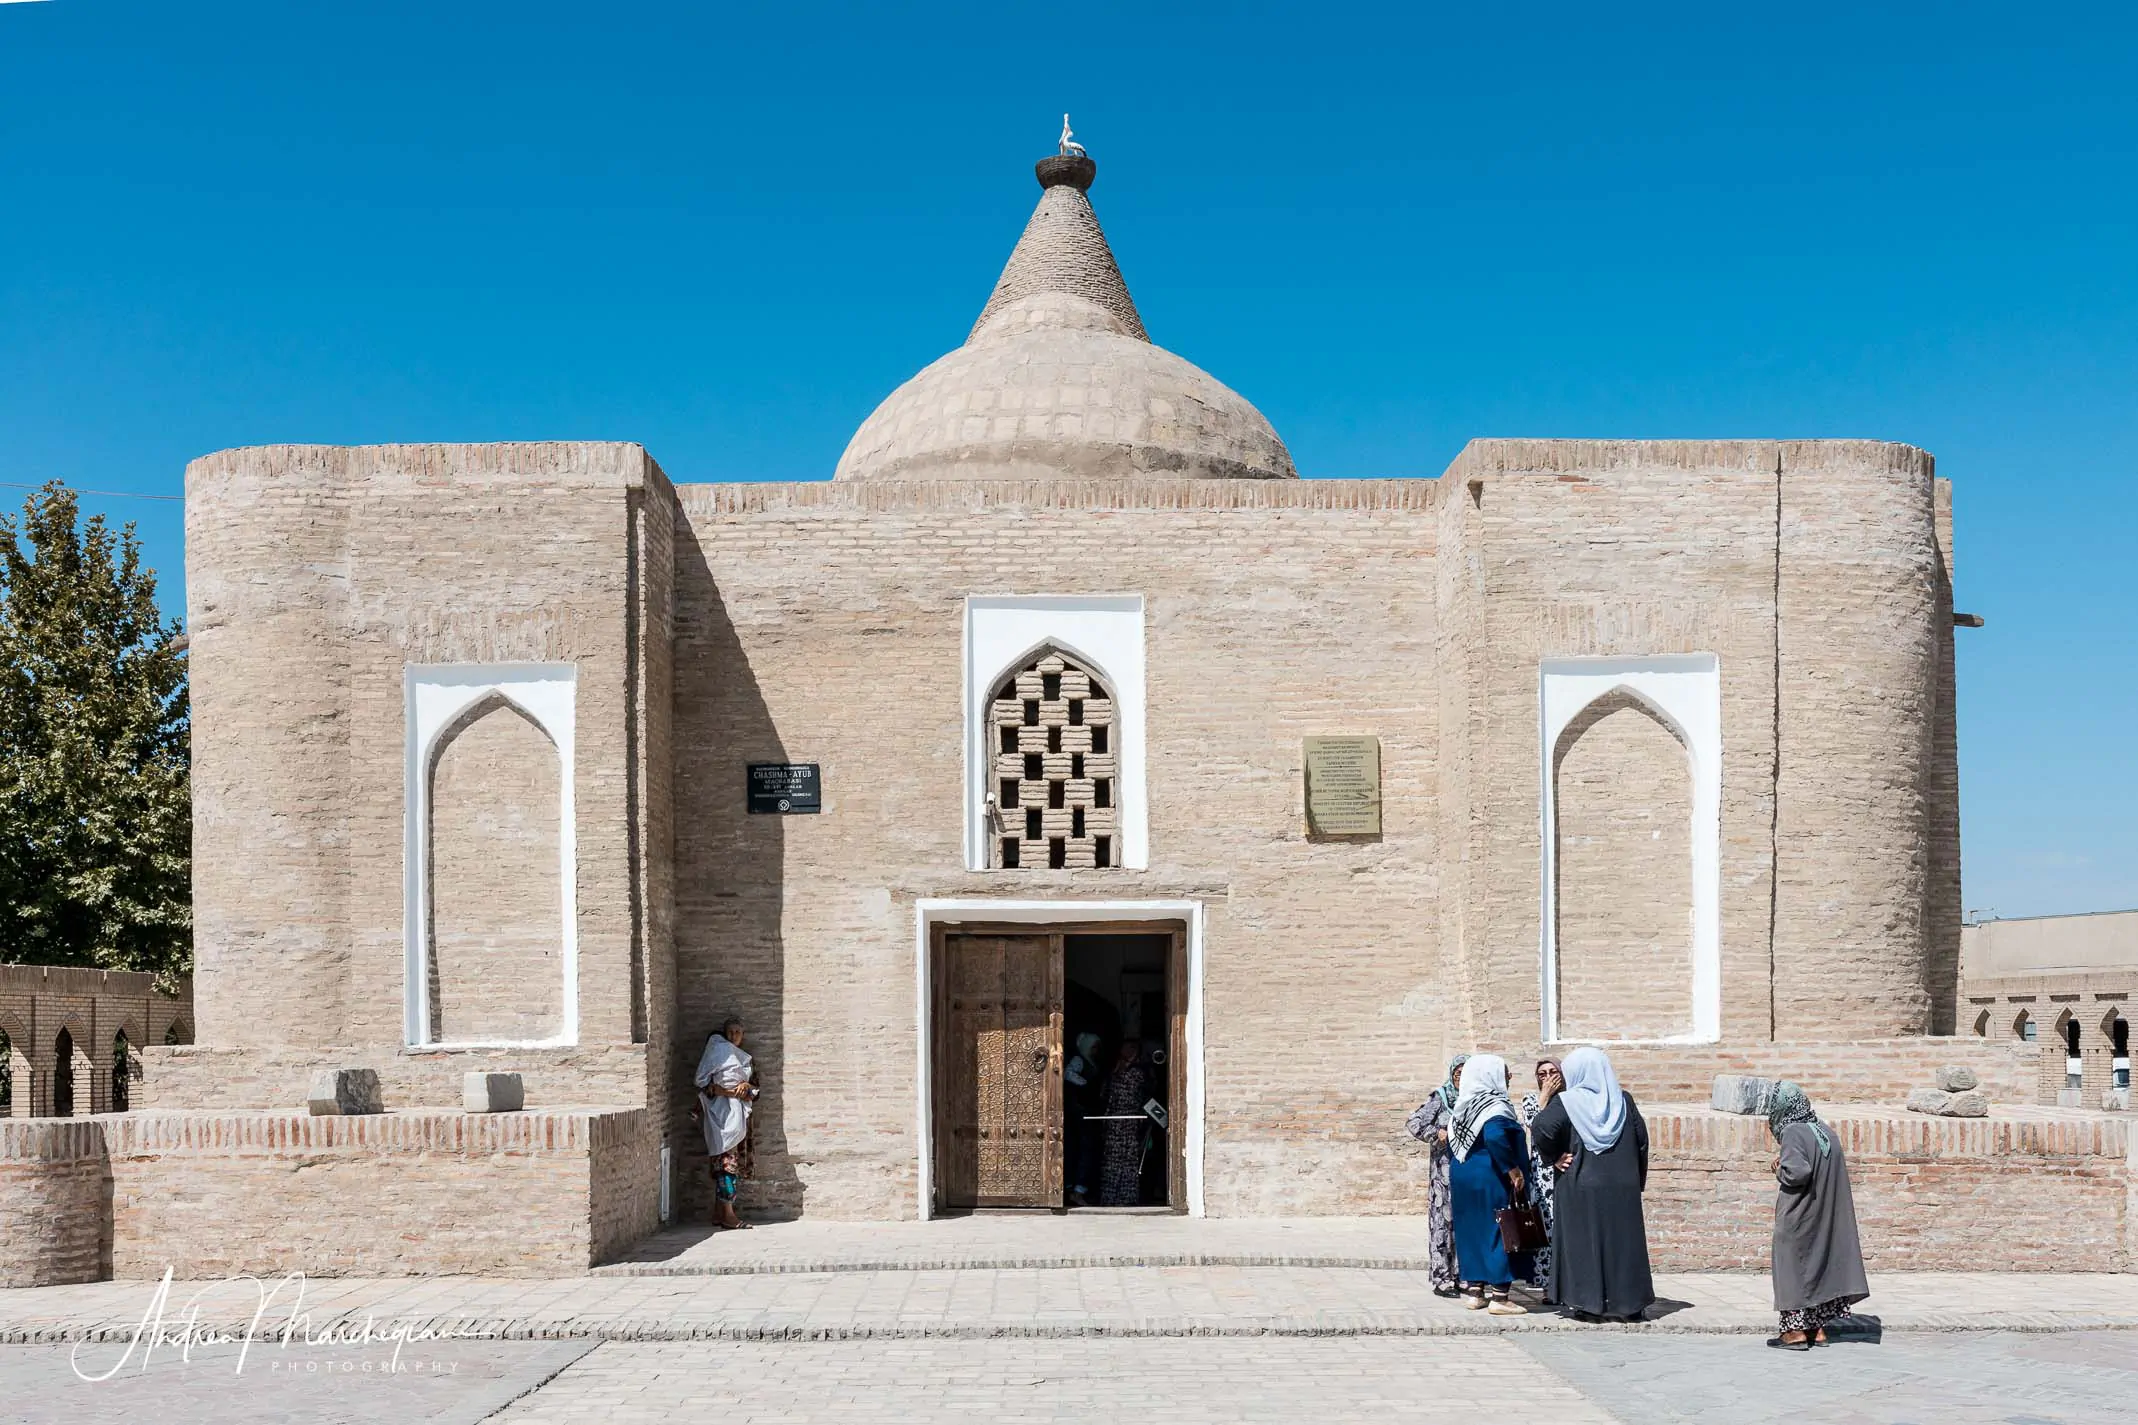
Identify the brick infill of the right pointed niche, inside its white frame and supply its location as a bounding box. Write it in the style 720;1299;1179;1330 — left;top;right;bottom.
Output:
1552;688;1693;1040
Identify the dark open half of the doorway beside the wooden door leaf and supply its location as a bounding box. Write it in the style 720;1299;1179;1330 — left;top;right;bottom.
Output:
1063;934;1174;1211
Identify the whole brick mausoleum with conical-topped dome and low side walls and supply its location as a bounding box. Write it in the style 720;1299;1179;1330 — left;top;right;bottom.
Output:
4;142;2127;1275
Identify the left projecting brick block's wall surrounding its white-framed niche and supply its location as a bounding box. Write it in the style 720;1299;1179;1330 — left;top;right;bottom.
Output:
187;442;669;1107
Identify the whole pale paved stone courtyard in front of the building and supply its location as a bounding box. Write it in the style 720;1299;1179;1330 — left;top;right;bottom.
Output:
12;1218;2138;1425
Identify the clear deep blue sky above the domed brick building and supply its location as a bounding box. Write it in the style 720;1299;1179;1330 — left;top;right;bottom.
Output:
0;0;2138;917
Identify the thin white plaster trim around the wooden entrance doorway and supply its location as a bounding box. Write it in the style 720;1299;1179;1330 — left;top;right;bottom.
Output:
913;899;1204;1222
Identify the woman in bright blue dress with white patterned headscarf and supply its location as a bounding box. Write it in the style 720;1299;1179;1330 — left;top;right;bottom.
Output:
1447;1053;1529;1316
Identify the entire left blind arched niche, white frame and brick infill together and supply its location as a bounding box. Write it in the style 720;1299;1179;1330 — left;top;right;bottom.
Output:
402;662;579;1049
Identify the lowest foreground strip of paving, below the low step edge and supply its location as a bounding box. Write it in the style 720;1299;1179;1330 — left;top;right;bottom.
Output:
12;1331;2138;1425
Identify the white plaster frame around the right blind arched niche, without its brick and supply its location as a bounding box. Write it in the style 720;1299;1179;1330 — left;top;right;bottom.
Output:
1537;654;1723;1045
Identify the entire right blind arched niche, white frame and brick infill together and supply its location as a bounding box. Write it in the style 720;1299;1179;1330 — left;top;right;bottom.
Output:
1537;654;1723;1045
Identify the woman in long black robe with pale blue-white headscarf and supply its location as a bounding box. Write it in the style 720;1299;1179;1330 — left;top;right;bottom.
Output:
1529;1049;1655;1320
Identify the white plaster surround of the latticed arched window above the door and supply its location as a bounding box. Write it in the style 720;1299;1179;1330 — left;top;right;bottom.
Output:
964;594;1150;872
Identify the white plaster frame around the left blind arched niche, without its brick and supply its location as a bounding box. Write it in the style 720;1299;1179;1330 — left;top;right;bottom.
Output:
402;662;579;1049
